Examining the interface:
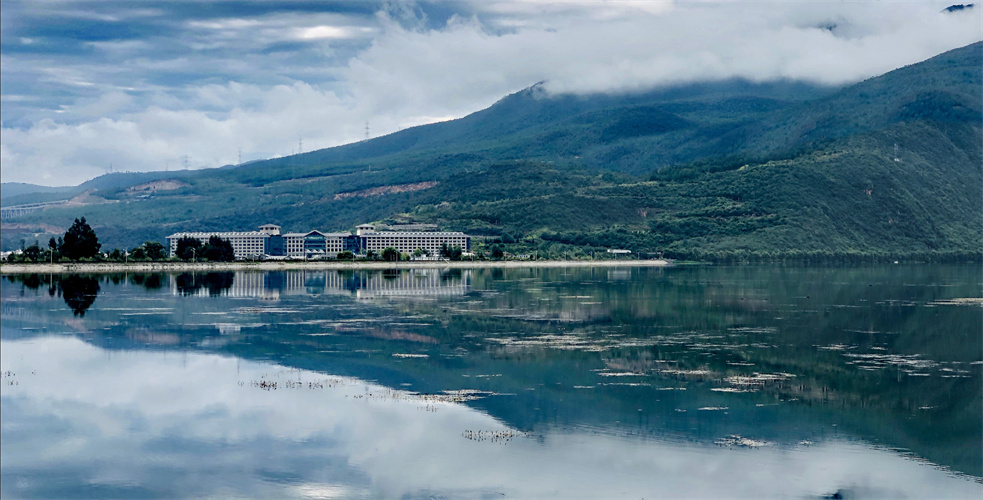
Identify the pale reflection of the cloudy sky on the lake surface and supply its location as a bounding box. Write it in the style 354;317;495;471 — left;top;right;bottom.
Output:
0;337;983;498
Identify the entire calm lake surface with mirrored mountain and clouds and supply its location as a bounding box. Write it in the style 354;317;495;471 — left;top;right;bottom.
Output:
0;266;983;499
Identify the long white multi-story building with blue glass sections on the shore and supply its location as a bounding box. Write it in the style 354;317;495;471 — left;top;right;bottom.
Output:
167;224;471;260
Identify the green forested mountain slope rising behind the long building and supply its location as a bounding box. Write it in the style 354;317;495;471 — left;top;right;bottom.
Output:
3;43;983;260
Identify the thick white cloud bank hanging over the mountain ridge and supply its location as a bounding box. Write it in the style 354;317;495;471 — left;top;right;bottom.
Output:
0;1;983;184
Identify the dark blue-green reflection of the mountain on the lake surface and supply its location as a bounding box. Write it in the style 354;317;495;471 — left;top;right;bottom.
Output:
3;266;983;480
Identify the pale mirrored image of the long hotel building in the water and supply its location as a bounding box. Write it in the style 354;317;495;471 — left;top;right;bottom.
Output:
170;269;472;300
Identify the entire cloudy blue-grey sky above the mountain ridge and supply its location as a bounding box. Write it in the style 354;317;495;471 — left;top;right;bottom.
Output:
0;0;983;186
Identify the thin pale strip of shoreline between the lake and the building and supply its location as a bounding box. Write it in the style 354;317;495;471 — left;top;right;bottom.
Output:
0;259;672;275
